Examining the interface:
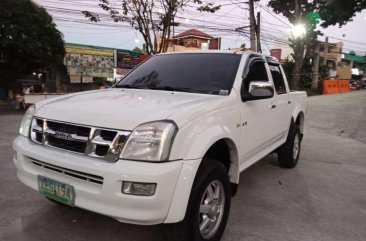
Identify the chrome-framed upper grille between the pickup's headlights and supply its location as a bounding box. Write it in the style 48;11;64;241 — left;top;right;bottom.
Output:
30;118;131;162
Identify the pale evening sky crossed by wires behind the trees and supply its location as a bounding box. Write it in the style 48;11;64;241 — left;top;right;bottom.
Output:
34;0;366;55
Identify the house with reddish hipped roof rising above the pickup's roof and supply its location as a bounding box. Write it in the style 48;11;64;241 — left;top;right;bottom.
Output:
158;29;221;52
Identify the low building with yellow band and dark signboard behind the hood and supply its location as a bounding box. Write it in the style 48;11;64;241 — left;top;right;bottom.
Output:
61;43;141;92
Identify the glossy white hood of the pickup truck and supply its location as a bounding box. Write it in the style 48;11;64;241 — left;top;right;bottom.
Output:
35;89;231;130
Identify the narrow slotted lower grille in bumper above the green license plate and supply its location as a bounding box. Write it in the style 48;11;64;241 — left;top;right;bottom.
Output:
28;157;103;185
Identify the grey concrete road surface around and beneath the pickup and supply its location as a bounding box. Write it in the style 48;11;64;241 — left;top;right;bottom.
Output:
0;91;366;241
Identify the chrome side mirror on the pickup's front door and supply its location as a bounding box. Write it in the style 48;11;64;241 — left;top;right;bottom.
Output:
242;81;274;101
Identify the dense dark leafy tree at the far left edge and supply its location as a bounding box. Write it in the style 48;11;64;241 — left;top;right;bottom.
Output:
0;0;65;93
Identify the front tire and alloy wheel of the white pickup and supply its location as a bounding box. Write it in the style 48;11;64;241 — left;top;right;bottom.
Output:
166;159;231;241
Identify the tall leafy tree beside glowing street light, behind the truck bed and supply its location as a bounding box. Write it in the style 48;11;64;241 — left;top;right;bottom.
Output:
268;0;366;89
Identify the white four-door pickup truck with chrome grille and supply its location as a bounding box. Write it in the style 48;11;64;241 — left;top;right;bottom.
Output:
13;51;306;241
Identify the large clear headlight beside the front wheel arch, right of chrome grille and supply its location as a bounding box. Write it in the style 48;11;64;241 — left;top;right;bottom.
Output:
121;121;178;161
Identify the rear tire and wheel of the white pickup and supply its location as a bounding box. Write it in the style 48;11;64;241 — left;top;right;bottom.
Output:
278;123;302;168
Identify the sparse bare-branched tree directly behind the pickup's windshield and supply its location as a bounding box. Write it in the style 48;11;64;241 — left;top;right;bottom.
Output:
83;0;220;54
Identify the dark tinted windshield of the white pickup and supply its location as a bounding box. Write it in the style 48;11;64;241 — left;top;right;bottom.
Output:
116;53;241;95
